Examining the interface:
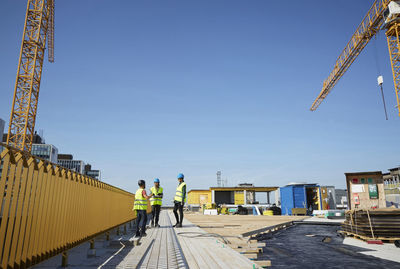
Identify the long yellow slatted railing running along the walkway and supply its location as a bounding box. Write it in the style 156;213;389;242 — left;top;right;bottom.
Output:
0;141;135;269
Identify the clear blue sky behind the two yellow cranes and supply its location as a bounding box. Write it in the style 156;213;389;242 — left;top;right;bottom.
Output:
0;0;400;202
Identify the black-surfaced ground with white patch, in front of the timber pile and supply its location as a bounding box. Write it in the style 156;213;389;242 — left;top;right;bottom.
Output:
258;221;400;269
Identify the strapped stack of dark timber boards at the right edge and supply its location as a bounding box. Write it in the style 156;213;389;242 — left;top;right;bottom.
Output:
342;208;400;240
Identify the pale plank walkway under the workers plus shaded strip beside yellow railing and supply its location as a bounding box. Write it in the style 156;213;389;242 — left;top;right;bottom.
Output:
33;210;259;269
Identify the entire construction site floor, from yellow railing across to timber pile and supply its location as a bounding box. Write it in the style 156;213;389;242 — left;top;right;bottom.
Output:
30;210;400;269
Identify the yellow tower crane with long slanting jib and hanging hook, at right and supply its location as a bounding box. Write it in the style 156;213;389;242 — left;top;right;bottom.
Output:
310;0;400;116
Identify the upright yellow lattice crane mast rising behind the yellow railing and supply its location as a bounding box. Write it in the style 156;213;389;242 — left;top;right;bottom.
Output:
7;0;55;152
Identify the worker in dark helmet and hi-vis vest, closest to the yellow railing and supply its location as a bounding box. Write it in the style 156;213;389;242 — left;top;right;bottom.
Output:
133;180;153;236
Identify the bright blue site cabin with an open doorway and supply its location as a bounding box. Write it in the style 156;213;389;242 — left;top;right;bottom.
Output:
280;183;328;215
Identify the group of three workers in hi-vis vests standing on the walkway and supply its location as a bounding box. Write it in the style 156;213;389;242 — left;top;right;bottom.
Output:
133;173;186;236
